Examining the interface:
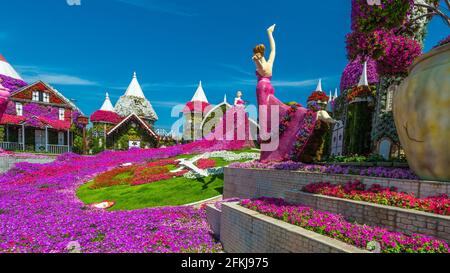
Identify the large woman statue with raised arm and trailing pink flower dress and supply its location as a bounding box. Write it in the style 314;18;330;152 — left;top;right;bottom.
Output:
253;25;334;162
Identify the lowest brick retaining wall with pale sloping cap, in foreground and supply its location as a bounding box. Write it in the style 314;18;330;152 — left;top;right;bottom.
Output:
220;203;368;253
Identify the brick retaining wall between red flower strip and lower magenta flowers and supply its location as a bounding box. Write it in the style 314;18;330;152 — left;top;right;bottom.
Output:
286;190;450;242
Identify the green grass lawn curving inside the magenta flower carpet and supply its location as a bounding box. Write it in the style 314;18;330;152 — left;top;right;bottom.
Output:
77;149;256;210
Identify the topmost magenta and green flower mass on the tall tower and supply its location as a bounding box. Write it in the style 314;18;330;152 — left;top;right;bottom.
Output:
352;0;414;32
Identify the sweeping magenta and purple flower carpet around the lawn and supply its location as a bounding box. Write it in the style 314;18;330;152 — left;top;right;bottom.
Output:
0;141;246;253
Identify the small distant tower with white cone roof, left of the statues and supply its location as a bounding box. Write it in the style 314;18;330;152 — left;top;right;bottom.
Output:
183;81;210;141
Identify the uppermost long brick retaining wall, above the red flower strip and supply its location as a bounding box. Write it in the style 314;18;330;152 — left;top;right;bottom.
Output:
224;168;450;199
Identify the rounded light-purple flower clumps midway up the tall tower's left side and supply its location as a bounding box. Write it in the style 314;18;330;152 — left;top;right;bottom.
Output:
341;56;379;90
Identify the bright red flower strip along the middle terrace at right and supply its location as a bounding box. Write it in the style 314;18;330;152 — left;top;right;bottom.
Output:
302;181;450;215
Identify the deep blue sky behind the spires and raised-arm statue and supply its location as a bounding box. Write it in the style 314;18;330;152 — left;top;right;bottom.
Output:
0;0;448;129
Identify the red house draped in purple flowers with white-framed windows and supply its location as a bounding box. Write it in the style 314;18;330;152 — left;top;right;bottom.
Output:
0;53;88;154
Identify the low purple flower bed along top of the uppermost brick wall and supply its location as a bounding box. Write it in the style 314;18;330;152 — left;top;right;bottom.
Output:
230;161;419;180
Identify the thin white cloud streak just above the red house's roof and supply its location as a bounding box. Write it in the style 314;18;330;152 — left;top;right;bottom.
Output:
16;65;99;86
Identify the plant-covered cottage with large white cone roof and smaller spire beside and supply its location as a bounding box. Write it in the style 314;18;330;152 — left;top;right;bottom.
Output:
90;73;159;154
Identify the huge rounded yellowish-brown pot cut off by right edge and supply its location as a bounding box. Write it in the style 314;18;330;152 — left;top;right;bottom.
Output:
393;44;450;181
